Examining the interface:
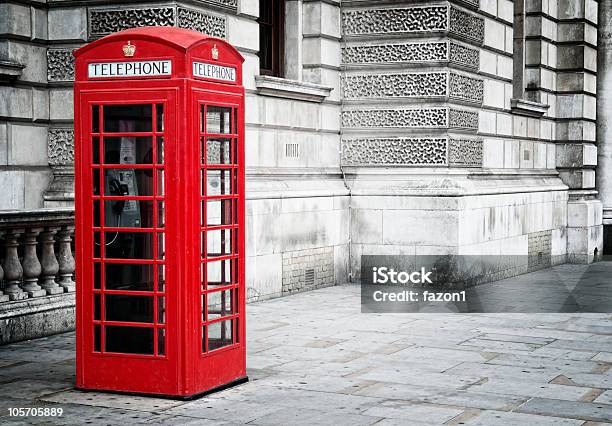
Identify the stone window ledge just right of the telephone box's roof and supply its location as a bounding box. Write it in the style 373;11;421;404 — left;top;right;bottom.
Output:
255;75;333;103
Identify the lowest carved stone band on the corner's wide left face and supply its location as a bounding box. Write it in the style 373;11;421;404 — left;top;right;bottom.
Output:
342;138;447;166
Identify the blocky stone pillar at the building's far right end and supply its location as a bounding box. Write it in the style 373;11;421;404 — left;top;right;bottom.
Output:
556;0;605;263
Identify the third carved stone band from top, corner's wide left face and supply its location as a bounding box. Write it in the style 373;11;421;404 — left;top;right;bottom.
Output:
342;72;448;98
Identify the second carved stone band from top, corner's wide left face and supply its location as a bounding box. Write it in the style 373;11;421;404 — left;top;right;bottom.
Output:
342;41;448;64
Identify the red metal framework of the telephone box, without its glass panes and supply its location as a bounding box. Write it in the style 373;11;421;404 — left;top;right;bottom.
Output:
75;27;246;397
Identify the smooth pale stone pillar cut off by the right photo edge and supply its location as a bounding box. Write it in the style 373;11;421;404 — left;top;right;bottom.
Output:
596;0;612;254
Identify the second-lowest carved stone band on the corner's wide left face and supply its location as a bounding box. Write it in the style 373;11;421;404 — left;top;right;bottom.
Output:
342;108;448;127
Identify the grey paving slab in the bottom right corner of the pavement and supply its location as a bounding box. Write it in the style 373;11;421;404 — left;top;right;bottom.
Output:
518;398;612;422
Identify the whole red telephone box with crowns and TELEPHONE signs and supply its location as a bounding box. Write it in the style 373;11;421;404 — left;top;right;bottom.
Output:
75;27;246;398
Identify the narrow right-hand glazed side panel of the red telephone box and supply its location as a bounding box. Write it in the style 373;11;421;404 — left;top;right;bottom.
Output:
193;91;246;388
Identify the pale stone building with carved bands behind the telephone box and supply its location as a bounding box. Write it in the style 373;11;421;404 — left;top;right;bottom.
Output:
0;0;612;342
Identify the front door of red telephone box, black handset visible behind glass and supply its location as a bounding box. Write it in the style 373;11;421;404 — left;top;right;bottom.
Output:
77;88;181;394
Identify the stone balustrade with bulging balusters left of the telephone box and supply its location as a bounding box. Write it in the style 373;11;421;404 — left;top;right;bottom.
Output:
0;208;75;303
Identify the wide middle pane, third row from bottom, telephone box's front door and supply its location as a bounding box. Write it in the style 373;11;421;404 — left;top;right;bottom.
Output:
104;263;154;291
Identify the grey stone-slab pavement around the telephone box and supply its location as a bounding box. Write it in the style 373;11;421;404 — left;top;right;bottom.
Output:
0;263;612;426
